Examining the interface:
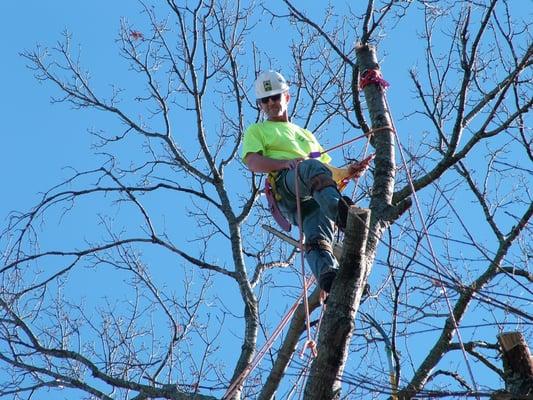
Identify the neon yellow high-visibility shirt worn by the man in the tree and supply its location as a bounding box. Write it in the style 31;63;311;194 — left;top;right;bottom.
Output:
242;121;331;164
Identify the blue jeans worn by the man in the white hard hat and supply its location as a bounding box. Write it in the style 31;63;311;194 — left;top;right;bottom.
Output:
276;159;341;280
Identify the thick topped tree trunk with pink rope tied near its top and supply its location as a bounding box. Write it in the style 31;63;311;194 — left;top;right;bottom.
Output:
305;42;396;400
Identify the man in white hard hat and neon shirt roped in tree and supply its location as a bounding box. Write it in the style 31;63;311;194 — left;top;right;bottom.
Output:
242;71;367;292
